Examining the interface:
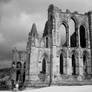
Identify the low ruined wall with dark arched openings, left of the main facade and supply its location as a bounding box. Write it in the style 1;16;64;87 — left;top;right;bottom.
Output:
11;48;27;87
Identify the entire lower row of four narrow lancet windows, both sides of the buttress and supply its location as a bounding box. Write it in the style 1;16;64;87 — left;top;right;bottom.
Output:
40;52;88;75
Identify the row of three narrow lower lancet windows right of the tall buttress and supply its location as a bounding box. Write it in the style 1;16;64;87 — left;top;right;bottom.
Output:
60;53;88;75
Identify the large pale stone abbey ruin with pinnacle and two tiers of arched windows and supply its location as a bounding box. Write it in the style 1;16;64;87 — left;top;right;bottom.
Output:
11;5;92;87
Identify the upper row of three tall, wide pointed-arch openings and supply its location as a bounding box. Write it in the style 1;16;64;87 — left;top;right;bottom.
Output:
58;18;88;48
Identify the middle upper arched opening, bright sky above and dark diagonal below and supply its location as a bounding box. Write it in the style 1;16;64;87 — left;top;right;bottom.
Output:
69;19;77;47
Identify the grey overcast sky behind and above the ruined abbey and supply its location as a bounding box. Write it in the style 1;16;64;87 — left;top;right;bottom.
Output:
0;0;92;67
